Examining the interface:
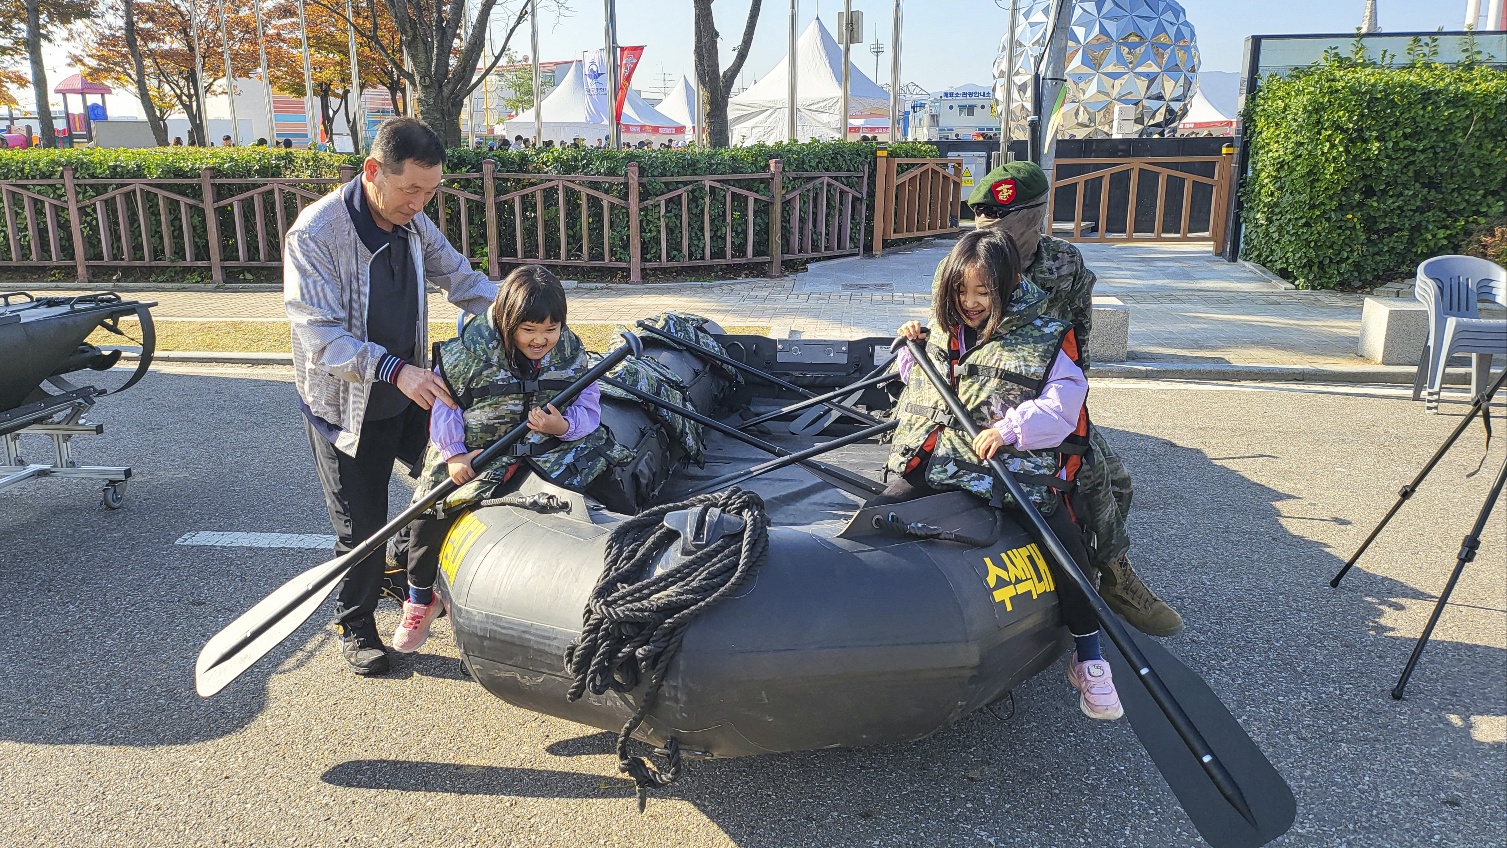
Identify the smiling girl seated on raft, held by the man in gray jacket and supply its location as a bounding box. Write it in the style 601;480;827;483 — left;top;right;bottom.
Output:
392;265;607;654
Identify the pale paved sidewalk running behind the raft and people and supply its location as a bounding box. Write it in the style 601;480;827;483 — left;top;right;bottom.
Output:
32;239;1411;380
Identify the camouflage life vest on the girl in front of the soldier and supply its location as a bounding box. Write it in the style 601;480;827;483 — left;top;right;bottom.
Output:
888;280;1070;512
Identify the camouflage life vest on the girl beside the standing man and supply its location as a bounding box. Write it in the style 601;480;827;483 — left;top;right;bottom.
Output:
414;310;631;512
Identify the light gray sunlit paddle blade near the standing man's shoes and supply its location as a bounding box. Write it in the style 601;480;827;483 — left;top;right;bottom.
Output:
193;554;354;697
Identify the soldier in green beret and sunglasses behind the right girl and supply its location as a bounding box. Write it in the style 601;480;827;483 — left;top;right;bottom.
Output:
967;161;1183;636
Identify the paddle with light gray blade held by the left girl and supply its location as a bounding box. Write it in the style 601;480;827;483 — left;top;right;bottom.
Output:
194;333;643;697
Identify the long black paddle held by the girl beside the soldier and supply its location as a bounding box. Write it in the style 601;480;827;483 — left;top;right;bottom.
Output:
906;339;1298;848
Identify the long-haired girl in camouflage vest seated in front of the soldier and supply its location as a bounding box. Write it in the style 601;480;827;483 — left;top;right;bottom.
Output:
870;229;1124;721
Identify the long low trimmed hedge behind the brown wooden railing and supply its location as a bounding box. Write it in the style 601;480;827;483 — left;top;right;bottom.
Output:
0;142;937;279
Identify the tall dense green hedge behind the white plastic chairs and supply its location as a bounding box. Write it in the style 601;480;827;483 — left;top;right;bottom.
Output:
1242;44;1507;289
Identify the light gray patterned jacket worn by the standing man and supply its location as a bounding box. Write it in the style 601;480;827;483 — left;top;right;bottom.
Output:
283;185;497;456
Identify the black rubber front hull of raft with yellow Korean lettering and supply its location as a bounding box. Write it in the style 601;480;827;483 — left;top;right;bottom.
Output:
439;480;1070;756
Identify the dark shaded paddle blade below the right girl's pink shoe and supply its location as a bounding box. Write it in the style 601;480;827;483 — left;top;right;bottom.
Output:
1103;631;1298;848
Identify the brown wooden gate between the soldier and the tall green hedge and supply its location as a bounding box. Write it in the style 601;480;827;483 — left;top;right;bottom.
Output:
1047;157;1231;253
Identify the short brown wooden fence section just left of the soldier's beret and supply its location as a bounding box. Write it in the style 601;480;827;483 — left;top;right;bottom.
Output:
873;152;963;256
